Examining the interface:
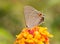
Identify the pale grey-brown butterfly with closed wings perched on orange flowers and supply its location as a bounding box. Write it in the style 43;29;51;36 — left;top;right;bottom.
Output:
24;6;44;28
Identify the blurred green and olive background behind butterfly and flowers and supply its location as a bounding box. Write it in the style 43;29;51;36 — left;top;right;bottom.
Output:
0;0;60;44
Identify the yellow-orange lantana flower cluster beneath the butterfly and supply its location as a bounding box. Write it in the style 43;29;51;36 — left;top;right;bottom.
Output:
14;26;53;44
